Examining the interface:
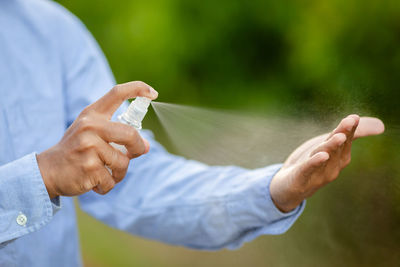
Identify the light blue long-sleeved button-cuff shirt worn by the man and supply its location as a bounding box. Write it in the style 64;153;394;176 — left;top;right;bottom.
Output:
0;0;304;267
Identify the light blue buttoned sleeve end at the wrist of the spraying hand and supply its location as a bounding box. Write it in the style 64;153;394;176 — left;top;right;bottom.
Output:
0;153;60;244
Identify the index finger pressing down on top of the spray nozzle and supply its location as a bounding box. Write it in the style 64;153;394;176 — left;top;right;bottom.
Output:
86;81;158;118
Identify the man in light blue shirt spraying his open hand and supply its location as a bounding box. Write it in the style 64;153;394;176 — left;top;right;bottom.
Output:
0;0;383;266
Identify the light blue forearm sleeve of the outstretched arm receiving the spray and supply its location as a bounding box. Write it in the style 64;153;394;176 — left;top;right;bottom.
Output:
79;132;304;250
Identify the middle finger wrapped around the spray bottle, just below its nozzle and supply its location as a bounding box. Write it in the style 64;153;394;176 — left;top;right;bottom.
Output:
93;121;149;159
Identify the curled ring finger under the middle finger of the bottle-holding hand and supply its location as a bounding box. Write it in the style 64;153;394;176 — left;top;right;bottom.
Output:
97;140;129;183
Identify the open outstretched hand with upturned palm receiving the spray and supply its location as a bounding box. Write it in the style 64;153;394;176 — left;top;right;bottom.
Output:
270;115;384;212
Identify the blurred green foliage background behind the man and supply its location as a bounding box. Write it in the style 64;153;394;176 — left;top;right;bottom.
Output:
59;0;400;267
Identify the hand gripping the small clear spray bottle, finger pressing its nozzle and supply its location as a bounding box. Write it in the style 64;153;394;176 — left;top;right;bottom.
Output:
37;82;158;198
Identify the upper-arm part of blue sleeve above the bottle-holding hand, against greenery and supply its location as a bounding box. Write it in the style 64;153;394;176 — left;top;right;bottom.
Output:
57;6;115;126
